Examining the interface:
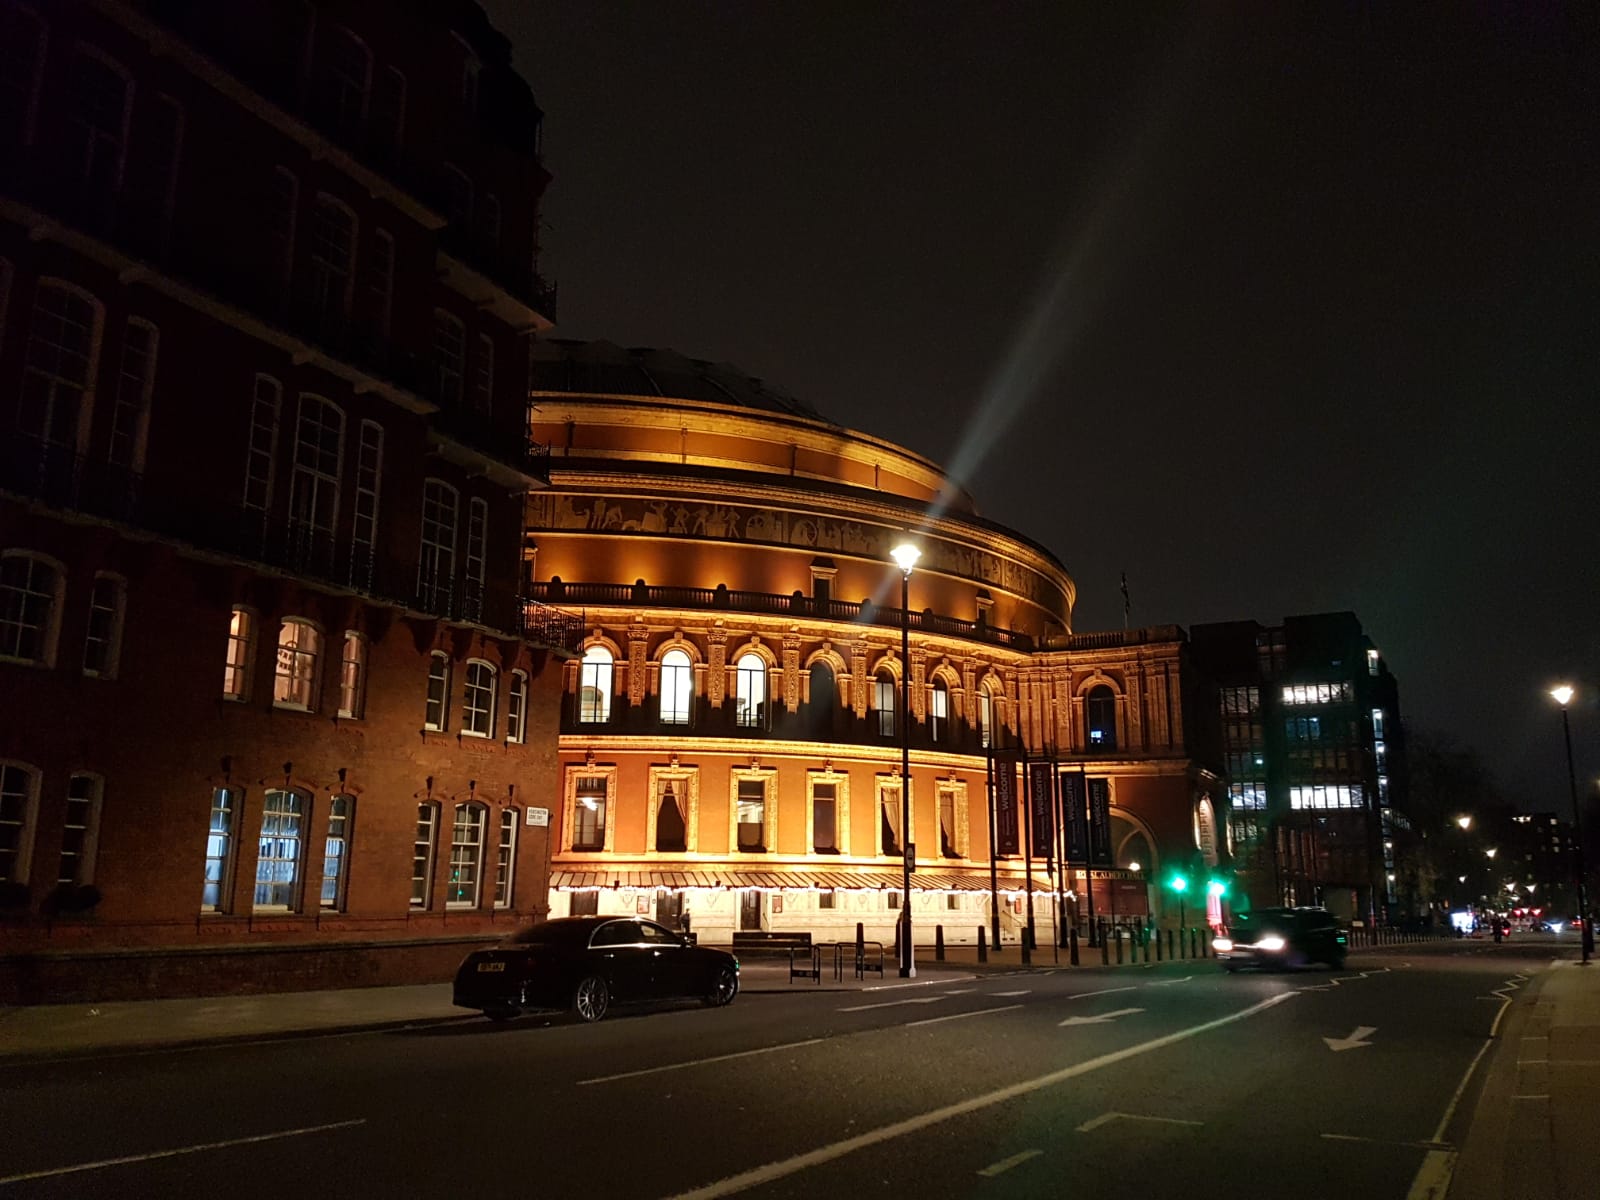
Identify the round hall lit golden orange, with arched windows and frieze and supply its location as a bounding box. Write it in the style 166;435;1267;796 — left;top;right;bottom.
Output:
525;339;1221;944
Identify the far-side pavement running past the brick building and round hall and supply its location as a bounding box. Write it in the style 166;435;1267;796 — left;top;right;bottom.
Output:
0;946;1043;1064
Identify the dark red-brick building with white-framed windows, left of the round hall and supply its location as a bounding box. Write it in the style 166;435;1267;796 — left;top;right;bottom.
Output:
0;0;574;1002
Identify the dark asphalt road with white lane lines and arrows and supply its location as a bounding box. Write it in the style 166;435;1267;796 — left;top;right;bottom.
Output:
0;942;1550;1200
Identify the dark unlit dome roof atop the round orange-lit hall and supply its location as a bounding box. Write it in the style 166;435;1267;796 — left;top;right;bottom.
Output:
533;338;835;426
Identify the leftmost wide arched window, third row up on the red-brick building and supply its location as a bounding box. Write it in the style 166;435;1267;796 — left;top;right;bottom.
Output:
18;282;101;454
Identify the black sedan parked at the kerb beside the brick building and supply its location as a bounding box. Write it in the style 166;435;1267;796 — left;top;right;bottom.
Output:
454;917;739;1021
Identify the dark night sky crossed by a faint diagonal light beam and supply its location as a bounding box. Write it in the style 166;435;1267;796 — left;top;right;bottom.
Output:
485;0;1600;814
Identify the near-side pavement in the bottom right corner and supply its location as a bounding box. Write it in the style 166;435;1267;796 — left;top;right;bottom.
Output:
1448;958;1600;1200
